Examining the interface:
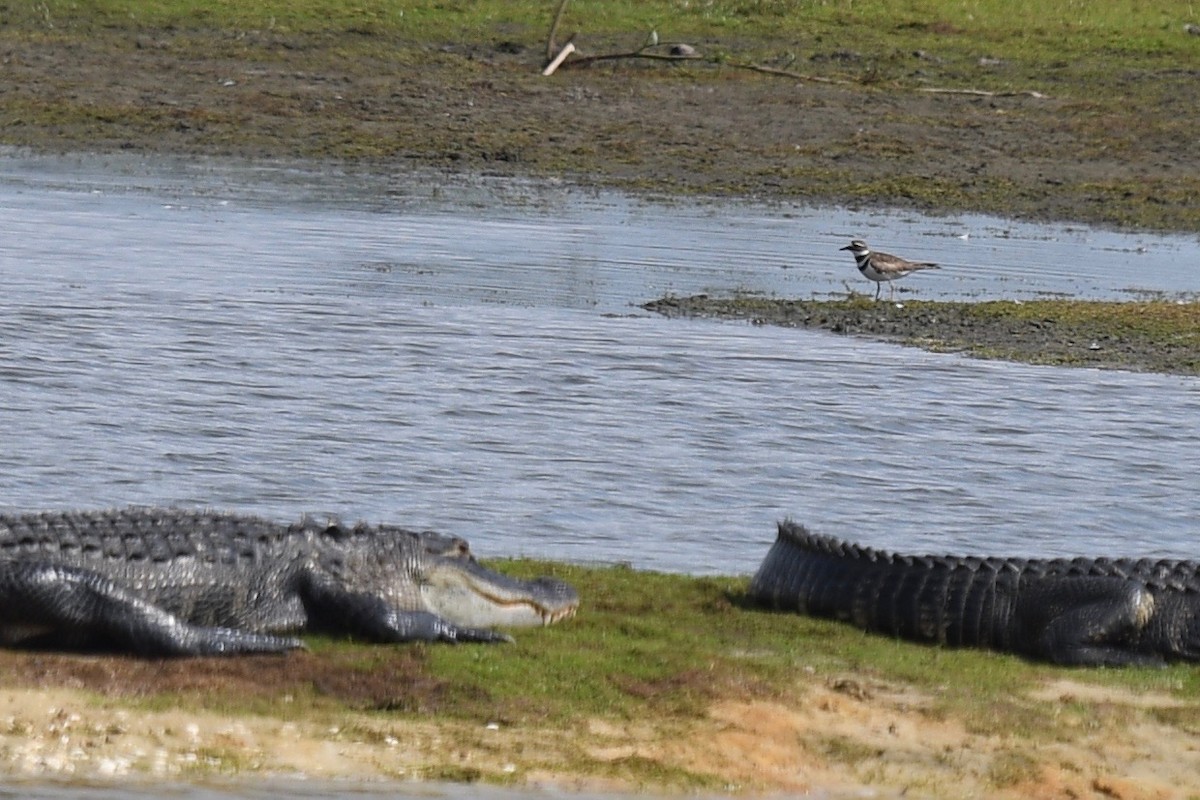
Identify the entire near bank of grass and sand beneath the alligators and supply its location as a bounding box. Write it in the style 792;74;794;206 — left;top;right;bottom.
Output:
0;560;1200;796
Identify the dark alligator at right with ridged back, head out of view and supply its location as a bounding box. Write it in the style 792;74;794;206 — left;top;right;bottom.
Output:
749;522;1200;666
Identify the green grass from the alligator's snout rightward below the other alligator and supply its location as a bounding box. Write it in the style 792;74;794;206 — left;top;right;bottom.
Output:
428;561;1200;740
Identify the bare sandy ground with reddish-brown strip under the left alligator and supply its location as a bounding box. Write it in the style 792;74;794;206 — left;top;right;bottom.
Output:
0;649;1200;800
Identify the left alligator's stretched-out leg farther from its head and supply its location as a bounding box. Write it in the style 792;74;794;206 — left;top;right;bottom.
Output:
0;561;304;656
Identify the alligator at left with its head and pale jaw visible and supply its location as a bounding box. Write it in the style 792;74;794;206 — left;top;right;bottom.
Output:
0;507;578;656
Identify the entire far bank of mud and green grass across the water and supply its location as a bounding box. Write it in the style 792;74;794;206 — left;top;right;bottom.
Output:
0;0;1200;230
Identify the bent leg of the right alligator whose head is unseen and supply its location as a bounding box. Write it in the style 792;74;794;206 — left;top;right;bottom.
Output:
1016;576;1164;667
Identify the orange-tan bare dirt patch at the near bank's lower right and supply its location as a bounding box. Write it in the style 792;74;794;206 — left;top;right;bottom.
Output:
686;688;1196;798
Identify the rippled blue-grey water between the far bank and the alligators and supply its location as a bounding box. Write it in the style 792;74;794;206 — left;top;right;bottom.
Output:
0;151;1200;573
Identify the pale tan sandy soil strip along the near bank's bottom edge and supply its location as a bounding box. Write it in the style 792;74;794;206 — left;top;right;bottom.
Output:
0;679;1200;800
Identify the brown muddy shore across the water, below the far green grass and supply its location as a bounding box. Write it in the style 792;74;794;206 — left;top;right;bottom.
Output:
0;20;1200;231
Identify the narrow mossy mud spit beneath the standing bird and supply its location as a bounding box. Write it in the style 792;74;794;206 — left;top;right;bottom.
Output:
643;295;1200;375
